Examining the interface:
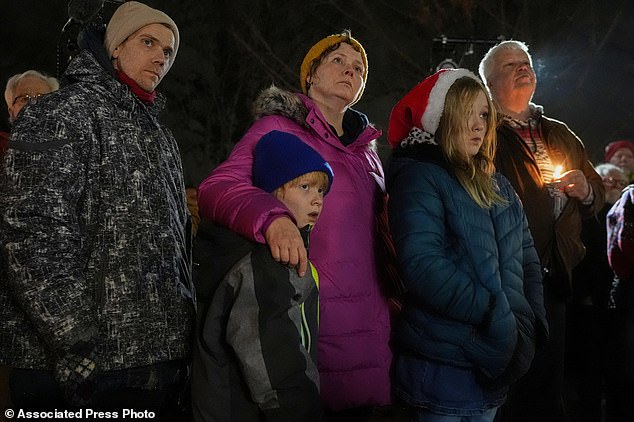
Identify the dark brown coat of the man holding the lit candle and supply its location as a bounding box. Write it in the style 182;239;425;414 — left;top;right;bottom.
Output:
495;116;605;299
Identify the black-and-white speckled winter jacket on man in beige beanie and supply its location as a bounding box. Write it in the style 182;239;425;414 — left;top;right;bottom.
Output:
0;44;192;370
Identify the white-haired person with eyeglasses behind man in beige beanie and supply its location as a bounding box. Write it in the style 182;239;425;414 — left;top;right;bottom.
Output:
0;69;59;157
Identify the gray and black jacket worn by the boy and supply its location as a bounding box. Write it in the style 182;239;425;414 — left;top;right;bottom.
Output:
192;220;321;422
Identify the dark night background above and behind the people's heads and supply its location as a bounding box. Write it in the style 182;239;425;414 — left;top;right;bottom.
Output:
0;0;634;184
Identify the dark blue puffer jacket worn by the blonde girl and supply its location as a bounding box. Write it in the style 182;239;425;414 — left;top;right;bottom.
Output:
388;146;546;407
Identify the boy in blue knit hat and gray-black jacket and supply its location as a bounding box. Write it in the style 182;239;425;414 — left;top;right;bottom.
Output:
192;131;334;422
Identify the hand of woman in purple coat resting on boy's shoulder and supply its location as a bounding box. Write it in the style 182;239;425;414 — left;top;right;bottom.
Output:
264;217;308;277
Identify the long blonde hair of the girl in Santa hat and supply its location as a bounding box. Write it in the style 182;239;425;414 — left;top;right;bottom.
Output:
436;77;505;208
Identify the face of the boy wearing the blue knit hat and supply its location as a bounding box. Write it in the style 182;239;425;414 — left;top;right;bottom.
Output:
276;175;326;227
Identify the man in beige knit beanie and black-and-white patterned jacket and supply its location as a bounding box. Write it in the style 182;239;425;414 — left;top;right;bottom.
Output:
0;1;193;421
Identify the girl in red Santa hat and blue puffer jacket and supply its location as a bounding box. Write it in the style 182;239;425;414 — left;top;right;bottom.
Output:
388;69;547;422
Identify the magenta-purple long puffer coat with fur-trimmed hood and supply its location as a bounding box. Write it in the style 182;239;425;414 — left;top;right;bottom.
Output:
199;87;392;410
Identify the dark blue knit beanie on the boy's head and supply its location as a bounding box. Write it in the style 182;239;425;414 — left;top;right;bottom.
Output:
253;130;334;193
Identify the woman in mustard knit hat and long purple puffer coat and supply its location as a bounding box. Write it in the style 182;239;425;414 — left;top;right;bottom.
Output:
199;32;392;421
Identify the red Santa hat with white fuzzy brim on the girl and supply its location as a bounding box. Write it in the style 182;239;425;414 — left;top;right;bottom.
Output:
387;69;480;148
